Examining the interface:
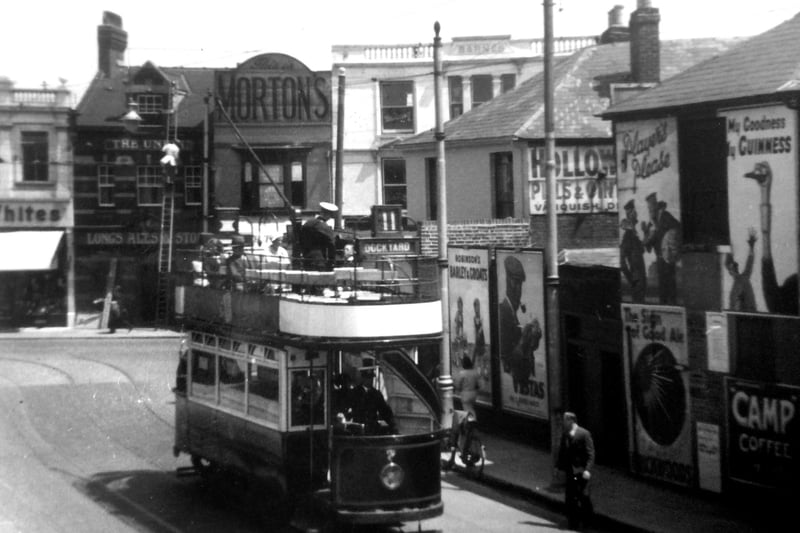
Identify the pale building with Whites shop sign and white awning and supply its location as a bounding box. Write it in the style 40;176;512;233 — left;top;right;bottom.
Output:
0;78;75;329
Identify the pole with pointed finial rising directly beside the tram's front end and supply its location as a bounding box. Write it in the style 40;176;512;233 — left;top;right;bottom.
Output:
433;21;453;428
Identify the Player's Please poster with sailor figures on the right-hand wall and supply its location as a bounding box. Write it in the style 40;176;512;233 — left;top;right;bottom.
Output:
616;118;682;305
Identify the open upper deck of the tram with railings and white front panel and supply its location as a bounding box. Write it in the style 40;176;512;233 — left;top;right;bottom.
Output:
175;252;442;340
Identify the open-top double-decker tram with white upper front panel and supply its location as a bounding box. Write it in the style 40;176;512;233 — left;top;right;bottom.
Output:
174;230;444;524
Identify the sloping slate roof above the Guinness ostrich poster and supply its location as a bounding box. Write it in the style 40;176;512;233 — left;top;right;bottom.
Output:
605;13;800;117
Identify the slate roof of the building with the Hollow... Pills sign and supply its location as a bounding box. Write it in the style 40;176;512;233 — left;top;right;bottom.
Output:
395;38;741;147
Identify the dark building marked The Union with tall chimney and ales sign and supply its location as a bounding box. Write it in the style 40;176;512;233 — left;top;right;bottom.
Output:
73;12;213;323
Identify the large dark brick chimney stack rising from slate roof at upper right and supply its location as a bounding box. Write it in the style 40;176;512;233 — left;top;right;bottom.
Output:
629;0;661;83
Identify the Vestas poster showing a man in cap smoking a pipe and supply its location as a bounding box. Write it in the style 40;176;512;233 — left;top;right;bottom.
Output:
495;250;549;420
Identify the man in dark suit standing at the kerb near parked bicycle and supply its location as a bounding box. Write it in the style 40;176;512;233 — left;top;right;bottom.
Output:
556;411;594;529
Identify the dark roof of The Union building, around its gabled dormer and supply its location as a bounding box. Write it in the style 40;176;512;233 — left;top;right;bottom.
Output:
76;61;214;127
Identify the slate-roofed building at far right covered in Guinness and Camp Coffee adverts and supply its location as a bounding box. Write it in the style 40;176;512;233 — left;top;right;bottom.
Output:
605;8;800;495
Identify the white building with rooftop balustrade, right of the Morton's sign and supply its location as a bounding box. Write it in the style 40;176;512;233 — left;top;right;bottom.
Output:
333;32;597;216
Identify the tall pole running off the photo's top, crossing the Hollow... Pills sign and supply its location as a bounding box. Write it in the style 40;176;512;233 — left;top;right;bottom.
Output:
544;0;563;484
